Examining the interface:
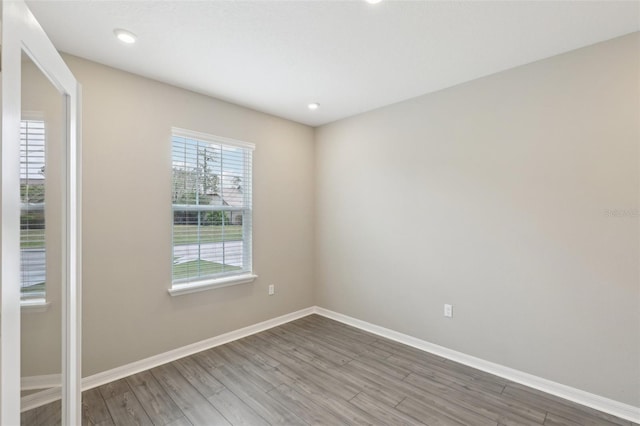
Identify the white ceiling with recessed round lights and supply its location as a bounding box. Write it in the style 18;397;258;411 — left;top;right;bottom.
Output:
27;0;640;126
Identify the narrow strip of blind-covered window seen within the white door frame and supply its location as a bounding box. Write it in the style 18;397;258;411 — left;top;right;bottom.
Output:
20;120;46;299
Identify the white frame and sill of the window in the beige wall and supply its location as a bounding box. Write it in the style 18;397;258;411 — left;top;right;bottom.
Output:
168;127;258;296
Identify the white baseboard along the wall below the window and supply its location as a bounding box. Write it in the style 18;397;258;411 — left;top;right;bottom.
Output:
20;307;315;411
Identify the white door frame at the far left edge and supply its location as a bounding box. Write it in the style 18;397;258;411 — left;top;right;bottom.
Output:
0;0;82;425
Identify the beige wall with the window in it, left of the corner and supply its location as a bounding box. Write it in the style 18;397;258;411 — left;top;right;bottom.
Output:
23;56;314;376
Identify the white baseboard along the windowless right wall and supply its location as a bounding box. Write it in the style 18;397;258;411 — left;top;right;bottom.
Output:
314;306;640;423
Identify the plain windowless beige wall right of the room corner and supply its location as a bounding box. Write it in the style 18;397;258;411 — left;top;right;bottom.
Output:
316;33;640;406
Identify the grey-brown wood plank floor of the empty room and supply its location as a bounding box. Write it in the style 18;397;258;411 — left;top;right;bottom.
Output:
22;315;637;426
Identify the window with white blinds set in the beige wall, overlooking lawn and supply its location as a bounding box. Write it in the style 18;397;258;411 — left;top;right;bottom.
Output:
170;128;255;294
